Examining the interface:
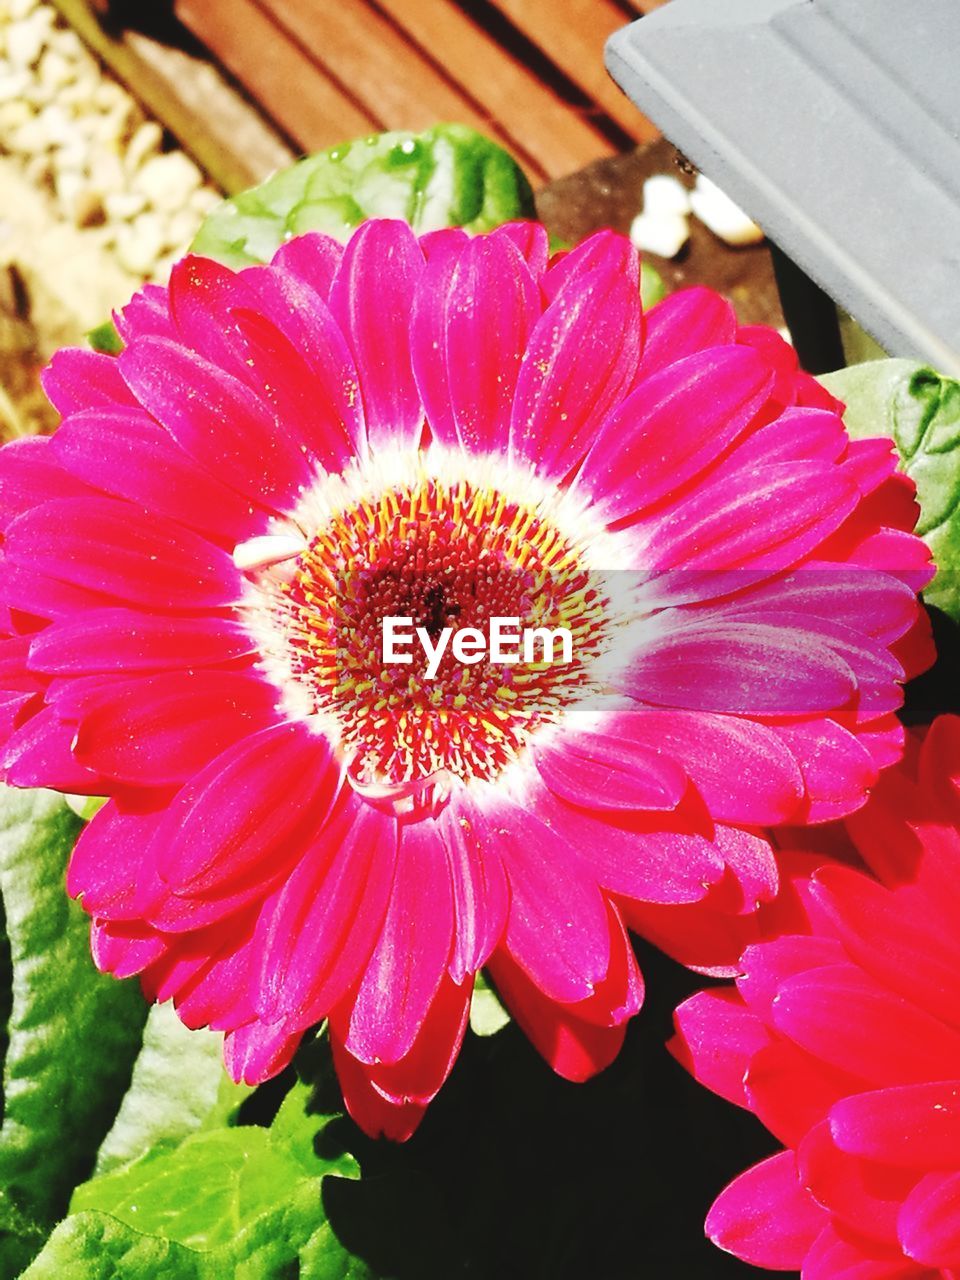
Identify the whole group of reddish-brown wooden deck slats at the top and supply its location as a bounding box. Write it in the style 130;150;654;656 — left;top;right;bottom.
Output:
174;0;664;186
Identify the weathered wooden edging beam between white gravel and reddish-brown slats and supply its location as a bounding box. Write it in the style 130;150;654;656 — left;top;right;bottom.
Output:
54;0;285;195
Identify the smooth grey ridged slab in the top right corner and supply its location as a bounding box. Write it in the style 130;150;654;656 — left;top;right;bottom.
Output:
607;0;960;376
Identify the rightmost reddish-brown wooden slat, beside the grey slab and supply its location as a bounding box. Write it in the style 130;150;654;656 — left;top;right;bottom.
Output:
494;0;658;142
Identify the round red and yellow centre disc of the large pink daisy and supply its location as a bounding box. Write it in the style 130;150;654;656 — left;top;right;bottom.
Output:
244;458;609;795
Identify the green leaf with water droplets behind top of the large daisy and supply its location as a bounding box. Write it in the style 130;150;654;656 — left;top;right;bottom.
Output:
193;124;534;268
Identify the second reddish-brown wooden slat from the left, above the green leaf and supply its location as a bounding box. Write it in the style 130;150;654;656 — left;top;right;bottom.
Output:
259;0;493;145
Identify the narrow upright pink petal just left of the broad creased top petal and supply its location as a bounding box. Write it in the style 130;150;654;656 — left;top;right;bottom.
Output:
330;219;424;448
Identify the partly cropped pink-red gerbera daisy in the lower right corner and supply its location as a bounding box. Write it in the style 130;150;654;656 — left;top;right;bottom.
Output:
675;717;960;1280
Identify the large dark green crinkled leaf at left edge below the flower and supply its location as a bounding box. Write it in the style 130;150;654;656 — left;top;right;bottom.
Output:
0;787;146;1224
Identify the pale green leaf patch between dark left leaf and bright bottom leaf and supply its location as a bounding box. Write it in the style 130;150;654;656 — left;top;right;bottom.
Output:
96;1005;252;1174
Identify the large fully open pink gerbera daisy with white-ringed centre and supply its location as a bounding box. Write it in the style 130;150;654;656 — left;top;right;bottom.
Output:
0;221;928;1135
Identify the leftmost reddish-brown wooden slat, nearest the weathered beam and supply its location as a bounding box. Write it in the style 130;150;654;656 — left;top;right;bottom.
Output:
174;0;383;151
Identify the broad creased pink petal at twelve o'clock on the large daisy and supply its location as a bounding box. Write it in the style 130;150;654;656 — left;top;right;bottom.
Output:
411;236;540;453
